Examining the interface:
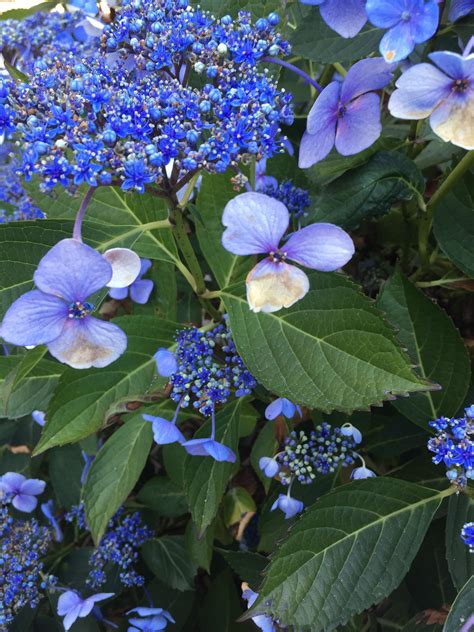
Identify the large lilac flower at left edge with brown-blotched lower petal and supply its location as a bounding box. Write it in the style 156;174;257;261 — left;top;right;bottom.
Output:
0;239;127;369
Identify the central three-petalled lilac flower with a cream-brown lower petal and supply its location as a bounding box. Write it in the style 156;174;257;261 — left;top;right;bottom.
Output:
222;192;354;312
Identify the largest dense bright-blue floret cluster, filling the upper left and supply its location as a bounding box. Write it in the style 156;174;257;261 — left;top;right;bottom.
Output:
0;0;293;193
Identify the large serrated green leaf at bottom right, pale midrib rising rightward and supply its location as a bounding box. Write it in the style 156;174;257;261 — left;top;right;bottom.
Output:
246;478;452;632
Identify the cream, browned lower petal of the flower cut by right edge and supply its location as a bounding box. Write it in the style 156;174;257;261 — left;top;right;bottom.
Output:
430;90;474;149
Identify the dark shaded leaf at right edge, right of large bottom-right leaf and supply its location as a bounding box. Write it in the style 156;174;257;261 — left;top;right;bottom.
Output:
446;494;474;590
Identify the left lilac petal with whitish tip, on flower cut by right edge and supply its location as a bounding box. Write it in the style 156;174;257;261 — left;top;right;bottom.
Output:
388;64;452;120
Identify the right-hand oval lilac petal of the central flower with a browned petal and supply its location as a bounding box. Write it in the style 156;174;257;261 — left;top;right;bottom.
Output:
285;224;354;272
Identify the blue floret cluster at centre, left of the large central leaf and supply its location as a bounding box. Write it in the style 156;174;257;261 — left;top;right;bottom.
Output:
165;324;257;417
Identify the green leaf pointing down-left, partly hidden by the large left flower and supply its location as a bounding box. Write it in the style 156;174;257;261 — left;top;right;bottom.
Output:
36;316;176;454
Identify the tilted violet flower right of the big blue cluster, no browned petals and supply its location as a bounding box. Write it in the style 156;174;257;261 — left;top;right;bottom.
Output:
299;57;392;169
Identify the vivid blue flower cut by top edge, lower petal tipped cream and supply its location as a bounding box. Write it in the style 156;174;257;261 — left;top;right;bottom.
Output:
365;0;439;63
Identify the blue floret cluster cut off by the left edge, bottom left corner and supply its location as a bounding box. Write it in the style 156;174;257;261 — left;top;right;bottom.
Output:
0;496;55;630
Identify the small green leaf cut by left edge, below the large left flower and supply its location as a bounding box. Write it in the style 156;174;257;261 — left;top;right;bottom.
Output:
0;350;64;419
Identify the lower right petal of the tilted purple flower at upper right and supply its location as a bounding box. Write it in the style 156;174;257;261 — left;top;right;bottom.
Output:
336;92;382;156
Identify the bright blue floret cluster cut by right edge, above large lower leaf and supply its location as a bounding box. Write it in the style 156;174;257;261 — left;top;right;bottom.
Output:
428;406;474;488
